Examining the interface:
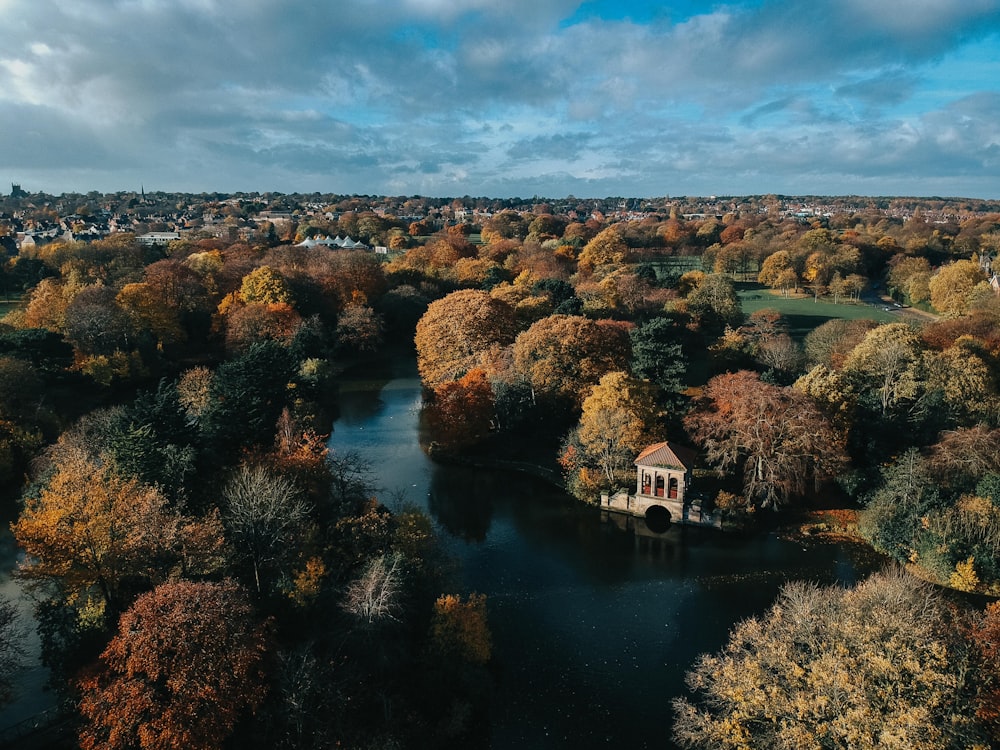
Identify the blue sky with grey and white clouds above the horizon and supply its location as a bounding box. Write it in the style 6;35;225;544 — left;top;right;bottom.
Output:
0;0;1000;199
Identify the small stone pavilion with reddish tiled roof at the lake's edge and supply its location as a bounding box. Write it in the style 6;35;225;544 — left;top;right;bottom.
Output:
601;441;720;528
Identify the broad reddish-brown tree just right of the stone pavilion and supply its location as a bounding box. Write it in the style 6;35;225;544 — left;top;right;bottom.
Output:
684;370;846;508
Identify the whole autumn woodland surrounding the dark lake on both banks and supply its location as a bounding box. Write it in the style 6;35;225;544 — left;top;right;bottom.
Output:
0;195;1000;748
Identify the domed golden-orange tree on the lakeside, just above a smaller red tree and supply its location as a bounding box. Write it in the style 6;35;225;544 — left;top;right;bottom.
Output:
414;289;515;388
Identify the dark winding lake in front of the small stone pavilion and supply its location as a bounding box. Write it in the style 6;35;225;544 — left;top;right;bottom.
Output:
330;359;884;750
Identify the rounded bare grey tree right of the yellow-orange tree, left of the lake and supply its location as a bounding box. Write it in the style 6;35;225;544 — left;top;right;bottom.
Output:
222;464;309;593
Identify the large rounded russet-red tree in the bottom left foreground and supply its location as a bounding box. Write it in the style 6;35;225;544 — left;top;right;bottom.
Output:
80;581;267;750
